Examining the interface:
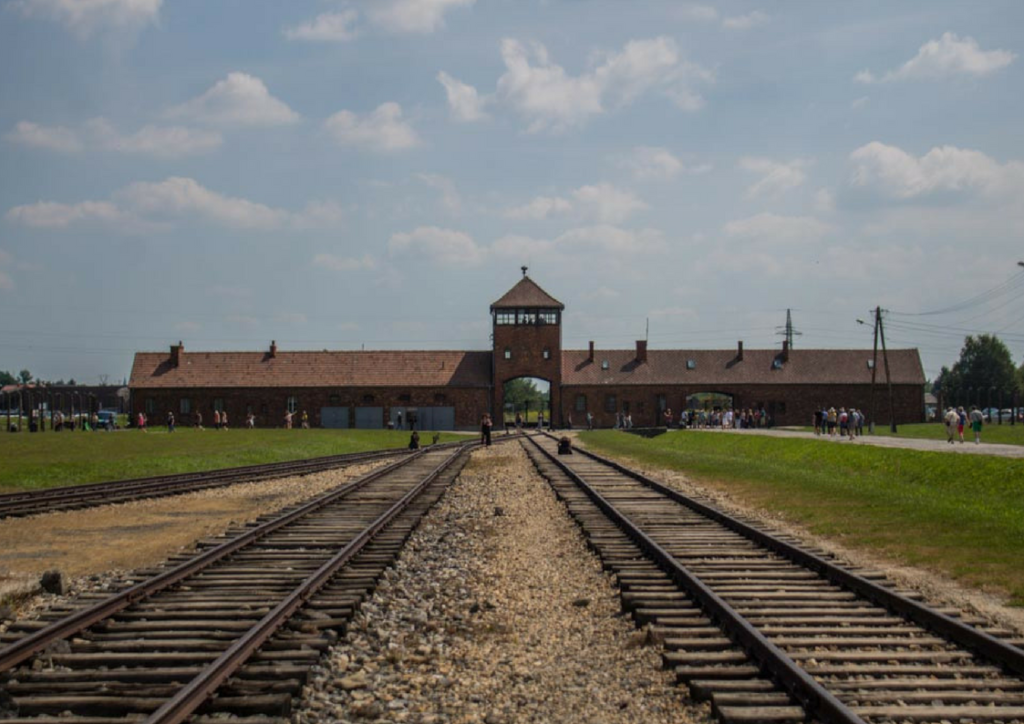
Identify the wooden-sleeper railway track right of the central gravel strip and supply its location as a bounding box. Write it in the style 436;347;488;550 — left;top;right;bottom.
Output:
526;436;1024;724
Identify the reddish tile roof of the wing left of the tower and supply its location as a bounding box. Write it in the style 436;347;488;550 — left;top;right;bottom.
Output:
129;351;490;389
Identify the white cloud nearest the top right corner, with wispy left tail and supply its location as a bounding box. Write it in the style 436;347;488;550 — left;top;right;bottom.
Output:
854;33;1017;83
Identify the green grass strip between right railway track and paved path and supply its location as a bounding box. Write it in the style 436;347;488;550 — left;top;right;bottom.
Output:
582;431;1024;605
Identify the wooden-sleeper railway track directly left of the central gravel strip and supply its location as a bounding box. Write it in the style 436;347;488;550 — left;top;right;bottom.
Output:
0;445;471;724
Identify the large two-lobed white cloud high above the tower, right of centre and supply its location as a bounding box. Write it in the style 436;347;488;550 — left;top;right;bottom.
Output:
498;37;714;132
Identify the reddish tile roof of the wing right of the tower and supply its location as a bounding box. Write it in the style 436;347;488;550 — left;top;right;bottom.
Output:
562;349;925;386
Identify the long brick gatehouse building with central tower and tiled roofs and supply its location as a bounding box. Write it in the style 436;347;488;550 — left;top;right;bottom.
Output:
129;268;925;430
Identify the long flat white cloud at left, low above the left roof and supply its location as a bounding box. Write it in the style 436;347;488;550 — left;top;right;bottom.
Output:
6;176;344;232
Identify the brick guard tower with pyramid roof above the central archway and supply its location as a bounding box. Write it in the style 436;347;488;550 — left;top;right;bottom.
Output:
490;266;565;424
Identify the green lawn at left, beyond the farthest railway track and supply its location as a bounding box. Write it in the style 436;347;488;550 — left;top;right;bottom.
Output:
0;427;464;493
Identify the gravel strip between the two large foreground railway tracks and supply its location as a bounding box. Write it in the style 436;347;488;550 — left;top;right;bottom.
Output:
292;444;711;724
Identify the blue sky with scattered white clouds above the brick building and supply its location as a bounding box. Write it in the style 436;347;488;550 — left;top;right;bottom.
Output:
0;0;1024;381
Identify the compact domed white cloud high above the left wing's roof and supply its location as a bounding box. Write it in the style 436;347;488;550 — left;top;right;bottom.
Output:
167;72;299;126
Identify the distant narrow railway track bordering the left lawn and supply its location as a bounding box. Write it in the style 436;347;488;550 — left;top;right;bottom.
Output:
0;443;423;518
